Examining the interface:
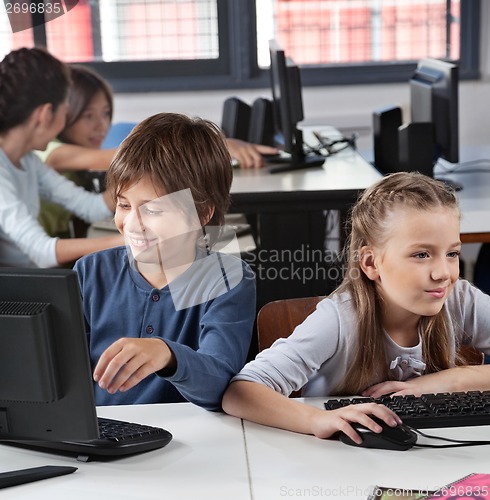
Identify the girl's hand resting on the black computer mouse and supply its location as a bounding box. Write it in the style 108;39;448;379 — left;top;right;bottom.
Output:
311;403;402;444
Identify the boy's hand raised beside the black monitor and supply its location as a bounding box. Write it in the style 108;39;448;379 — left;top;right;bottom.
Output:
94;337;175;394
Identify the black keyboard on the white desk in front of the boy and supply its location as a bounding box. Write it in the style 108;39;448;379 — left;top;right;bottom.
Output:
6;417;172;462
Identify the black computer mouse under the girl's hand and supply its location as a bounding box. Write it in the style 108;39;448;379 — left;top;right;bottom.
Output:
339;418;417;451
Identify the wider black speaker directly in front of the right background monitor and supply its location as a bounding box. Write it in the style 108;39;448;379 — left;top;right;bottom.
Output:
398;122;434;177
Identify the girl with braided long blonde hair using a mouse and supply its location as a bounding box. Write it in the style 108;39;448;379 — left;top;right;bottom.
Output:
223;173;490;443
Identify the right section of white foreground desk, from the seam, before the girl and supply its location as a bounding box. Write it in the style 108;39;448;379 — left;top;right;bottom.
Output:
245;398;490;500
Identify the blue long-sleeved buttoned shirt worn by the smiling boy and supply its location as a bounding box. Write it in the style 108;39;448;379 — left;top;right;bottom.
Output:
75;247;255;410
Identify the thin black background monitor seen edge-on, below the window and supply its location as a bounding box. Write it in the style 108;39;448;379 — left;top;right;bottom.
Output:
269;40;325;170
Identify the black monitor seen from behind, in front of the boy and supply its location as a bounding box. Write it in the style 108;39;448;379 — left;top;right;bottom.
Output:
0;268;98;441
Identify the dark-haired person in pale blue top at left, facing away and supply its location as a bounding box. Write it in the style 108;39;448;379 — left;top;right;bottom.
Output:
0;49;121;267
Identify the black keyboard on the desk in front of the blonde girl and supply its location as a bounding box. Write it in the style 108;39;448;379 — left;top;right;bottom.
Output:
325;391;490;429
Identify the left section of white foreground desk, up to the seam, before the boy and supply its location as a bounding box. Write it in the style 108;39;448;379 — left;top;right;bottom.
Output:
0;403;250;500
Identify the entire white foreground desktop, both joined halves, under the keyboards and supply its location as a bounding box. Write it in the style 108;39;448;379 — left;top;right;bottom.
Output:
0;398;490;500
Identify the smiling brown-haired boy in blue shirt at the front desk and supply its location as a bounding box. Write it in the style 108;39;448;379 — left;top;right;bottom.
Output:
75;113;255;410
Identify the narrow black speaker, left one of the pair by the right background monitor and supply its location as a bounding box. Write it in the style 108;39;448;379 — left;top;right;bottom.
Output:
373;106;402;174
